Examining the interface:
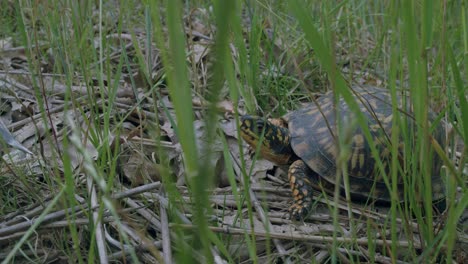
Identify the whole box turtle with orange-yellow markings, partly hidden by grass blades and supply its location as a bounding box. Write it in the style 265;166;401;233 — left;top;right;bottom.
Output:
240;86;445;219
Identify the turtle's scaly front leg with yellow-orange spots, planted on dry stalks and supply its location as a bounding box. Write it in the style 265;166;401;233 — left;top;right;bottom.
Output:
288;160;318;220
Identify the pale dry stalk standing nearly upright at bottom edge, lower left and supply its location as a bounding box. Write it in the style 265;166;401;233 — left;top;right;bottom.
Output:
87;176;109;264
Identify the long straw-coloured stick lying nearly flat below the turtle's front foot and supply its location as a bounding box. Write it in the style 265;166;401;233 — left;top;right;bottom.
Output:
171;224;422;249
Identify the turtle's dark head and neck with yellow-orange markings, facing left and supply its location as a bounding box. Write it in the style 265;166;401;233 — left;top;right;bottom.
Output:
240;115;294;165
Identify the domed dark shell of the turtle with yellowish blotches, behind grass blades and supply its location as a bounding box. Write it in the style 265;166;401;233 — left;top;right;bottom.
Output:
284;87;445;201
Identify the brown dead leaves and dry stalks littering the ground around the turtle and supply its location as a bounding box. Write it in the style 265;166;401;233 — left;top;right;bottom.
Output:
0;2;468;263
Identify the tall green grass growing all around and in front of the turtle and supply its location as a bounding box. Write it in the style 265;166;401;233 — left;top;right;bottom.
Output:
0;0;468;263
